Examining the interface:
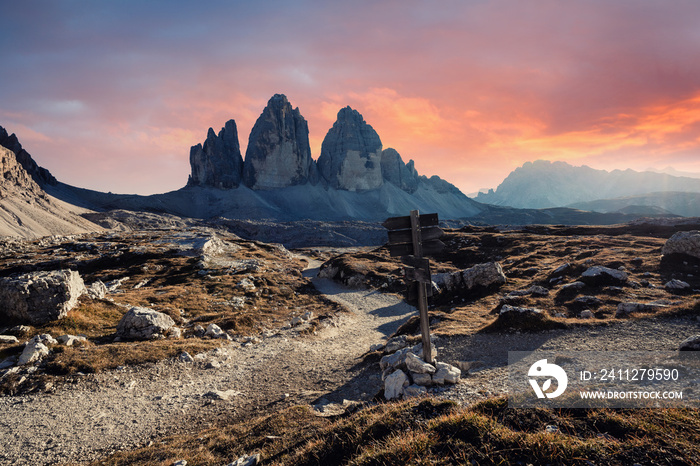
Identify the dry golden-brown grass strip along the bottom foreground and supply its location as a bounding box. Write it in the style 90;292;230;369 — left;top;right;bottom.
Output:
89;398;700;466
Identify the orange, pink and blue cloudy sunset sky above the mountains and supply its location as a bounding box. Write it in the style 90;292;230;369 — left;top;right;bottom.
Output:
0;0;700;194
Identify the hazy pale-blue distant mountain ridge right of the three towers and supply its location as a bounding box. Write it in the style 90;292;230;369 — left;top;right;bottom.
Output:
475;160;700;209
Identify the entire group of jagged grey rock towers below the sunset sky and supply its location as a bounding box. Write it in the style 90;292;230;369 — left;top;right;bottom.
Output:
187;94;468;202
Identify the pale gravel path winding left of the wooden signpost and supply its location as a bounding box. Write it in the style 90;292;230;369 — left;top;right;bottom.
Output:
0;261;415;465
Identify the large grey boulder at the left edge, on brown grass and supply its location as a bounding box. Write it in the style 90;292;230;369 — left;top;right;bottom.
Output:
0;270;85;325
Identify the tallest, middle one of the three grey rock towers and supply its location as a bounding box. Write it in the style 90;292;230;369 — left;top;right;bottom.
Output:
243;94;318;189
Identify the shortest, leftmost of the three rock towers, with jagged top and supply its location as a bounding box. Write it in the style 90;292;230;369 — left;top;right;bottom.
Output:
187;120;243;189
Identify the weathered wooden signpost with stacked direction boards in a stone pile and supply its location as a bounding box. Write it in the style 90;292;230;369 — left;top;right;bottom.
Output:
382;210;445;363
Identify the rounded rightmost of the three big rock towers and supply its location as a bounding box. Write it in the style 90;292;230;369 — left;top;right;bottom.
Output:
318;107;383;191
